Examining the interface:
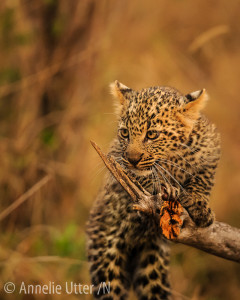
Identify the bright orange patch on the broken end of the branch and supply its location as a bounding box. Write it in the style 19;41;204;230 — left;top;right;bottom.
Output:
160;199;183;239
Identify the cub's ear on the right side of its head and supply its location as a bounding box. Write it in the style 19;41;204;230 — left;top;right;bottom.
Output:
183;89;208;120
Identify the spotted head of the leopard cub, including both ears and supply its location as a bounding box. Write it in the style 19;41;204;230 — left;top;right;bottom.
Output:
111;81;207;174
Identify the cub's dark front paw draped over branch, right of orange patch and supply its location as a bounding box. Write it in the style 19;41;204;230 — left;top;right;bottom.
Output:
188;206;215;227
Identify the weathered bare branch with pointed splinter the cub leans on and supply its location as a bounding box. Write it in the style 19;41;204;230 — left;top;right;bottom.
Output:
91;142;240;263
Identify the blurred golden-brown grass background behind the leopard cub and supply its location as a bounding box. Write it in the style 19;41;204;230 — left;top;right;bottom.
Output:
0;0;240;300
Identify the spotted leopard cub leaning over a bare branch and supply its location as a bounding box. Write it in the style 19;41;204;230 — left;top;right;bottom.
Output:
87;82;220;300
